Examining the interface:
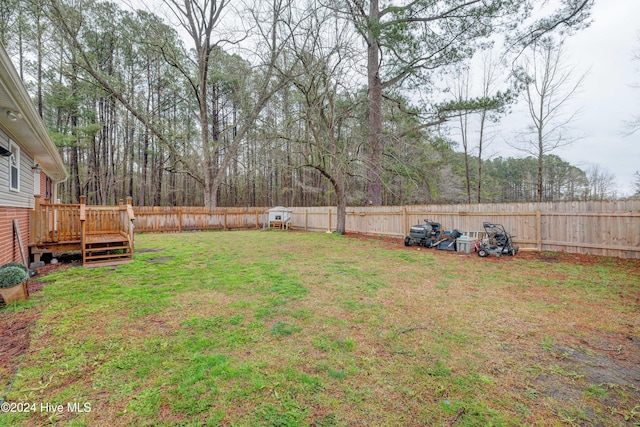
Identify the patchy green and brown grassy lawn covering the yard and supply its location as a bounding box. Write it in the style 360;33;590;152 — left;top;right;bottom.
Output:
0;231;640;426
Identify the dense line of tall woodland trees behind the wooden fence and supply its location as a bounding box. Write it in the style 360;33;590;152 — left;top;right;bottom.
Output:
0;0;624;232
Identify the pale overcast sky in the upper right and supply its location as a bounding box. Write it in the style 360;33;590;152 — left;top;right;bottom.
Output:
500;0;640;196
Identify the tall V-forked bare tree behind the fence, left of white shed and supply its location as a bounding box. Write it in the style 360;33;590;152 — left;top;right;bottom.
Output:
158;0;290;208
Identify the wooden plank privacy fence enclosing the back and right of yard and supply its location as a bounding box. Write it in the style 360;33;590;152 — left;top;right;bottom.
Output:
135;200;640;258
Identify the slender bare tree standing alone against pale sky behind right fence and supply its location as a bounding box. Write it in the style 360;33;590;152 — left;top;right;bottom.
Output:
510;38;586;201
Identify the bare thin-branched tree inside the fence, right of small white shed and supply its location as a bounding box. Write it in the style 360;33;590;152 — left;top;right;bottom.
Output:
278;2;359;233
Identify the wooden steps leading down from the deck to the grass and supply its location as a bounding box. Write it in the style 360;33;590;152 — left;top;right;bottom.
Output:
82;232;133;267
